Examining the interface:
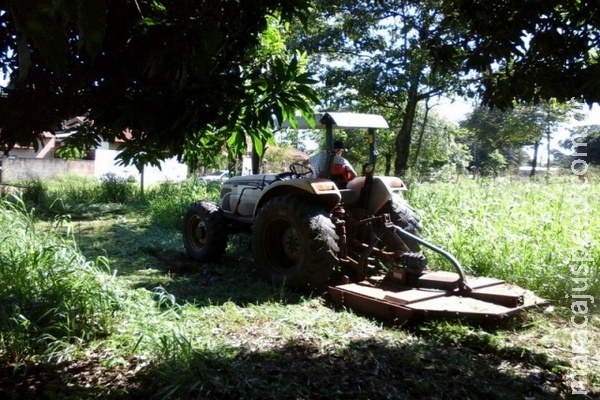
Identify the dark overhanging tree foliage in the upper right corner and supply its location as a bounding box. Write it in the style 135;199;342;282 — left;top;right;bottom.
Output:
441;0;600;108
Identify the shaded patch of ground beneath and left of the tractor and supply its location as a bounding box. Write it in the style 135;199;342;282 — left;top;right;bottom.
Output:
75;216;313;306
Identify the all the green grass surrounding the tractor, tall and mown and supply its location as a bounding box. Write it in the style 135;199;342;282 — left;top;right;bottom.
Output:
0;173;600;399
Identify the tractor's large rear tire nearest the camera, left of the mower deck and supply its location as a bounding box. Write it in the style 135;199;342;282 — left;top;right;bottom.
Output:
252;196;339;289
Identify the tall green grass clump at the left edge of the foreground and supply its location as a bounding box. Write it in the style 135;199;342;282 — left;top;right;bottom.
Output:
0;201;120;360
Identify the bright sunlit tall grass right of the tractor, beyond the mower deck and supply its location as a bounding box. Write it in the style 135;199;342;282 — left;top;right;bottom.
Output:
407;178;600;303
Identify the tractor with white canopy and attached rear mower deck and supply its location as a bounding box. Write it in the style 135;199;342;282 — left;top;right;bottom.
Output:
183;112;546;321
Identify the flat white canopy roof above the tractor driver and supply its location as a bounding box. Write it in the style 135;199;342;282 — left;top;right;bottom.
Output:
281;112;389;129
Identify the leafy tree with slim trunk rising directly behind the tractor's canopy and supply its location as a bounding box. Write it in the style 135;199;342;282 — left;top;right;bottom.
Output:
296;0;462;175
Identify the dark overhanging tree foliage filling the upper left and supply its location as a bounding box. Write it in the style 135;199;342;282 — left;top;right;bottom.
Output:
0;0;318;170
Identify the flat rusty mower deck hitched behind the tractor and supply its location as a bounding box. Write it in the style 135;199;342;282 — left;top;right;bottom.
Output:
328;271;548;323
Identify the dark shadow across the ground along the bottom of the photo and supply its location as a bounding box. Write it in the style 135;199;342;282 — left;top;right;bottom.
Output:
0;332;584;400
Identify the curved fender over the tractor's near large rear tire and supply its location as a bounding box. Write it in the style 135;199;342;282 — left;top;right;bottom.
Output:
254;178;342;216
